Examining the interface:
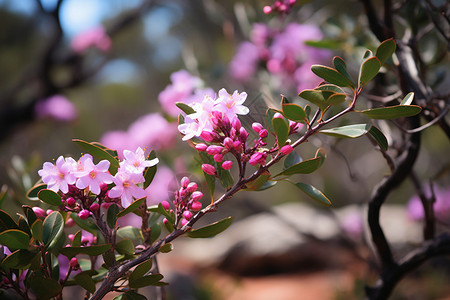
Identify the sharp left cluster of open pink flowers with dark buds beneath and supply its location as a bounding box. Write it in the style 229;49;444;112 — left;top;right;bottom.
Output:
38;148;158;219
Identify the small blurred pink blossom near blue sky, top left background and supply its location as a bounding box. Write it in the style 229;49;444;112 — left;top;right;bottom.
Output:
70;26;112;53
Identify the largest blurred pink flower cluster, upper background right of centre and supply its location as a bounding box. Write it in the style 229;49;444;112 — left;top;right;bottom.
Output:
229;23;331;92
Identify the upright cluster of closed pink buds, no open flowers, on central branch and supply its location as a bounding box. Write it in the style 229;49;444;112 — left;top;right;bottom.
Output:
161;177;203;226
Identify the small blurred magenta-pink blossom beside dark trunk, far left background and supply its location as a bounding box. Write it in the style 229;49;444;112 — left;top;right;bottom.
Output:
35;95;78;122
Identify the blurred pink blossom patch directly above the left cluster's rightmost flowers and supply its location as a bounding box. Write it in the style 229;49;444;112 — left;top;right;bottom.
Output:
100;113;178;159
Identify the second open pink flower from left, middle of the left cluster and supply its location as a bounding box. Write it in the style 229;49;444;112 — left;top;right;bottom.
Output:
75;156;113;195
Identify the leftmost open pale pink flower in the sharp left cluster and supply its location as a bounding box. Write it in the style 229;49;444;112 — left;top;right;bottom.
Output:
38;156;76;194
